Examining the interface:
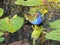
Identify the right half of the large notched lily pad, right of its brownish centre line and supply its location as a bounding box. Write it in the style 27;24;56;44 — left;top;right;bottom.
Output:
9;16;24;33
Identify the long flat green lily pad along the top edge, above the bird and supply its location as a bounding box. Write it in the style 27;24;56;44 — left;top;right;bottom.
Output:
15;0;40;6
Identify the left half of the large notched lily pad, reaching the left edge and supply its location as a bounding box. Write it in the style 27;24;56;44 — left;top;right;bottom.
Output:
0;17;9;31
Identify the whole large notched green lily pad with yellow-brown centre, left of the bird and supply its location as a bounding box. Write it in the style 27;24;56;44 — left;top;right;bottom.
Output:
0;15;24;33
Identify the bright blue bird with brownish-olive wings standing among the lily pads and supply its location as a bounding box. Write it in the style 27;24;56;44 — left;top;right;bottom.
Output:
25;12;42;25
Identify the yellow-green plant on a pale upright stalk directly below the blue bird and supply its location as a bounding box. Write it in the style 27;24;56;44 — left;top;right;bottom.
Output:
31;26;44;45
